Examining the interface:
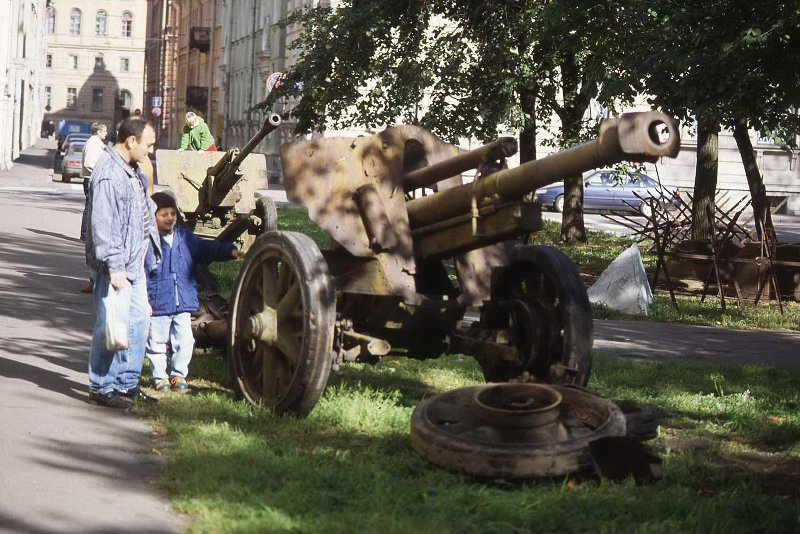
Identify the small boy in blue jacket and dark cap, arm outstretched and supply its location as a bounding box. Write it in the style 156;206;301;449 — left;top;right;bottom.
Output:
146;193;242;393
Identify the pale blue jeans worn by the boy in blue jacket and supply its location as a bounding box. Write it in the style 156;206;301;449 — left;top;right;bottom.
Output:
147;312;194;380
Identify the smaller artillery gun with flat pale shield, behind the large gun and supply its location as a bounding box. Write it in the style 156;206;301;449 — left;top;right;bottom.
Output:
156;114;281;250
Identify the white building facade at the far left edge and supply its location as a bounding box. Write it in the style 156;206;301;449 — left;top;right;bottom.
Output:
0;0;45;170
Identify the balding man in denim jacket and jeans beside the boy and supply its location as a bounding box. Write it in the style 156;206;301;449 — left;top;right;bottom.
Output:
86;118;161;408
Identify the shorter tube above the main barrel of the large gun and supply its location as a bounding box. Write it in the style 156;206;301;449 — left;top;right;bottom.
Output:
403;137;517;192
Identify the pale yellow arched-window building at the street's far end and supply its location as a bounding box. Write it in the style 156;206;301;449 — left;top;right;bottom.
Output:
45;0;147;136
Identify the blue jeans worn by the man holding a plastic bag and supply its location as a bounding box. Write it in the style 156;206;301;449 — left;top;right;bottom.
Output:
89;271;150;394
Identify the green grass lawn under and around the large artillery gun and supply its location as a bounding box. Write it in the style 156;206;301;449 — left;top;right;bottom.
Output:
145;208;800;534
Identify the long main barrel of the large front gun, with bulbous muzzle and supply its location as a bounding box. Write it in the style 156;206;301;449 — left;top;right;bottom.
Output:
406;111;680;228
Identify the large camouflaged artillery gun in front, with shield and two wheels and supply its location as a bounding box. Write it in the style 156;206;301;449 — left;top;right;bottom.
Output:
222;112;679;415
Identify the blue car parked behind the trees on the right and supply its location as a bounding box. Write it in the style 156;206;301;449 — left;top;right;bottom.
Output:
536;169;679;217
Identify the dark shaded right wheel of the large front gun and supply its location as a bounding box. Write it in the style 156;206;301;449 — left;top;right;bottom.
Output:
481;246;592;386
